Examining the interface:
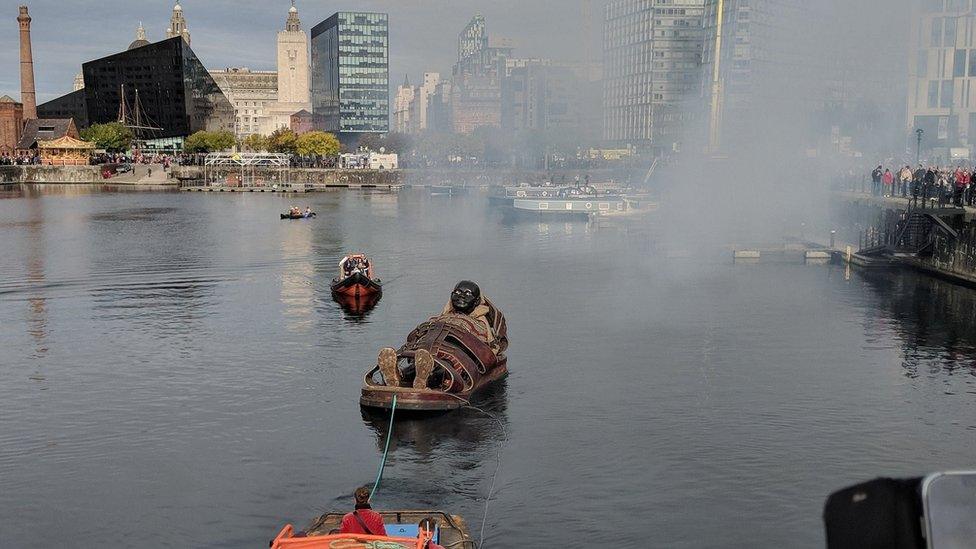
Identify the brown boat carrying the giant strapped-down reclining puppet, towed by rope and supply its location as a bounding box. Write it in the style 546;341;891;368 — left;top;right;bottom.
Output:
359;280;508;412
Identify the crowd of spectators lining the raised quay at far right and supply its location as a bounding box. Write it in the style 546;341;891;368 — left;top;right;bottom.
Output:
871;164;976;207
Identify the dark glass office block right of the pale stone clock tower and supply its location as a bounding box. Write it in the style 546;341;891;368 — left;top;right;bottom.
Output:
311;12;390;136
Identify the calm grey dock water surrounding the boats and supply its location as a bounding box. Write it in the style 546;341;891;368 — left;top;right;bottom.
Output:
0;187;976;548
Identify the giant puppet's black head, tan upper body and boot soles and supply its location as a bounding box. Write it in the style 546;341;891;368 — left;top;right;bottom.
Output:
377;280;508;389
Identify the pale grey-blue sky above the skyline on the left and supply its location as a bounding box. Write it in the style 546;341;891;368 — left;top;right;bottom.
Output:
0;0;605;103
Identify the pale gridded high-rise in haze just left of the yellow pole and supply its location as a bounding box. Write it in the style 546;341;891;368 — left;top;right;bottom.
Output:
603;0;705;150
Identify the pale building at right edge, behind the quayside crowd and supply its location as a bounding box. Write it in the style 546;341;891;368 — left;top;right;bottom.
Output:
907;0;976;152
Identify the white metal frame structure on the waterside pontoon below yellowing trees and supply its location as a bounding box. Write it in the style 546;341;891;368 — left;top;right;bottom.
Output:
203;152;290;187
